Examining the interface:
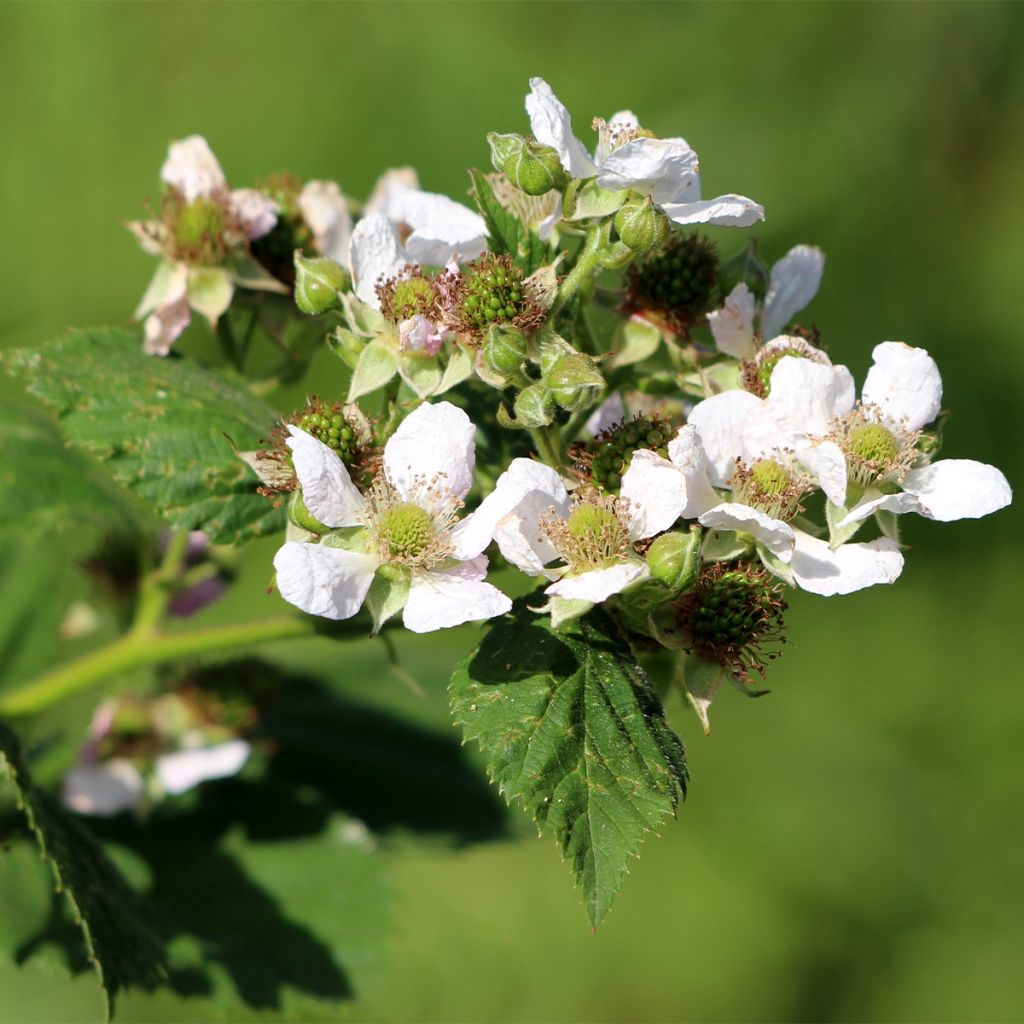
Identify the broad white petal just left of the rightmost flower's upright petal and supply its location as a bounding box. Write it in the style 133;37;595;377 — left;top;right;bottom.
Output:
766;355;856;437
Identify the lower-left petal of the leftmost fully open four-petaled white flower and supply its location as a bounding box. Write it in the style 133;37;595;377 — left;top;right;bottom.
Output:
273;542;380;618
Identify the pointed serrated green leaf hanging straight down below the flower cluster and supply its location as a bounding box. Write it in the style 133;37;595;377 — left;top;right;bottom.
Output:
451;604;687;926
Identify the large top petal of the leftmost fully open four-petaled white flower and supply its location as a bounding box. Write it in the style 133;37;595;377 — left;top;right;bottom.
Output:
384;401;476;501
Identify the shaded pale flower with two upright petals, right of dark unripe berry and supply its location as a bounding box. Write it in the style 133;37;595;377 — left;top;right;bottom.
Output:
708;246;825;359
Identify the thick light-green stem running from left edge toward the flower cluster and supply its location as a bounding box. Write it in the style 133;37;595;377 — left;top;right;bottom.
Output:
0;615;348;715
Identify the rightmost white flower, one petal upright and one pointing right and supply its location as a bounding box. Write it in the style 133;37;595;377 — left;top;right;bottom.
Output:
835;341;1013;528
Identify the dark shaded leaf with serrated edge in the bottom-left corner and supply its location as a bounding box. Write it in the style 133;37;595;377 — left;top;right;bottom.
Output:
0;722;165;1014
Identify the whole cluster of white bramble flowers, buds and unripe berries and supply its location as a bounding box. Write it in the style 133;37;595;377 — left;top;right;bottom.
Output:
123;78;1011;737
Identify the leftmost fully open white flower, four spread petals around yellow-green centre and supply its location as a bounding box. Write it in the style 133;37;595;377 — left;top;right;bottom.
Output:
273;402;512;633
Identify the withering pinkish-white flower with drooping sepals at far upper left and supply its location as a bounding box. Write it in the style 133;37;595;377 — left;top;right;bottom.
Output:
128;135;287;355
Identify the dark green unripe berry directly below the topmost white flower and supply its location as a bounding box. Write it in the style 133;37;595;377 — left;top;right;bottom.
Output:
629;233;719;330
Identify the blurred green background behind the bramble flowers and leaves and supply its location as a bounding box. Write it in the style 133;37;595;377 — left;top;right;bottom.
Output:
0;3;1024;1021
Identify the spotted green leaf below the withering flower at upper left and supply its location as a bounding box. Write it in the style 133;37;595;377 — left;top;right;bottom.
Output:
0;328;285;544
